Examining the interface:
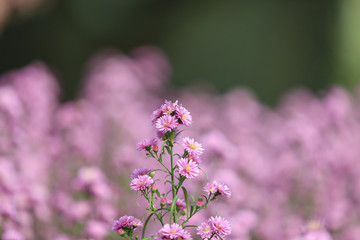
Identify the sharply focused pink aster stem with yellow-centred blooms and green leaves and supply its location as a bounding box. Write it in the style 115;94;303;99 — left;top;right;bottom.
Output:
113;101;231;240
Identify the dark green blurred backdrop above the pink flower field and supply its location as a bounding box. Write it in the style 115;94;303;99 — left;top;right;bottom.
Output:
0;0;360;105
